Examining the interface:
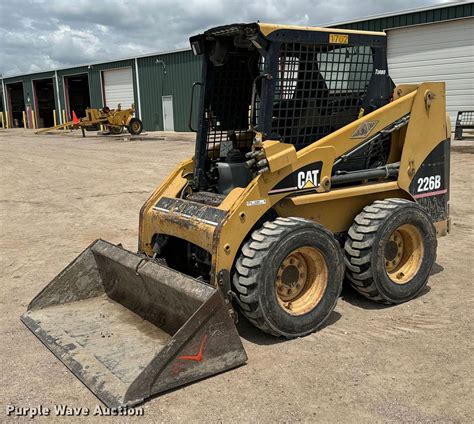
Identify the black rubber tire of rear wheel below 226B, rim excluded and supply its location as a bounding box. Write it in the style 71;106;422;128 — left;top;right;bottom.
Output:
344;199;437;303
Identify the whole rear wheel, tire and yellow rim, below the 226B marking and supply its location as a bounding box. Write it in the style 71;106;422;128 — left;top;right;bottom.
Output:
344;199;437;303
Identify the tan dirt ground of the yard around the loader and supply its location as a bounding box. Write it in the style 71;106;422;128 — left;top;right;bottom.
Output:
0;129;474;423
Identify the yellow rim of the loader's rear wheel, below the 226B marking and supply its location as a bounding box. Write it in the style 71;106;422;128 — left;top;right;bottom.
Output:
384;224;424;284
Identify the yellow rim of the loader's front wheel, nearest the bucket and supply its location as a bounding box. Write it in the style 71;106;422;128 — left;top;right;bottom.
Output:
275;247;328;315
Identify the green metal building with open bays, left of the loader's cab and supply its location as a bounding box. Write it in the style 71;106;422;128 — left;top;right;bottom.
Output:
0;49;201;131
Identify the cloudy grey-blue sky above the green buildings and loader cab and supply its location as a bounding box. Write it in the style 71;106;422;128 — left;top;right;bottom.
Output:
0;0;460;77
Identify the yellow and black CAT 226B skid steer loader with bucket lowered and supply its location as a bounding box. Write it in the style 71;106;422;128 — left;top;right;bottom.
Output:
22;23;450;407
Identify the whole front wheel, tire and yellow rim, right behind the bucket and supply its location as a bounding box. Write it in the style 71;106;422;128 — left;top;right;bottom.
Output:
233;218;344;338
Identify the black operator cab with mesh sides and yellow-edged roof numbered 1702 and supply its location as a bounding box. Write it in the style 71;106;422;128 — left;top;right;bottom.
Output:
190;23;394;194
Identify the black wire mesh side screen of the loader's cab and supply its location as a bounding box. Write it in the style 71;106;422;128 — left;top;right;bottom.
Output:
271;43;374;149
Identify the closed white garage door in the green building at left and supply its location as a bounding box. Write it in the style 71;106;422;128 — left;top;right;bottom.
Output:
102;68;135;109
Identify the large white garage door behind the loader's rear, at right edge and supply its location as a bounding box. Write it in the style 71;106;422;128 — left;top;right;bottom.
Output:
388;18;474;130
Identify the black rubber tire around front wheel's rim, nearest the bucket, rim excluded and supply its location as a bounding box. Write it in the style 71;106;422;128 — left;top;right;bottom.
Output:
232;218;344;338
